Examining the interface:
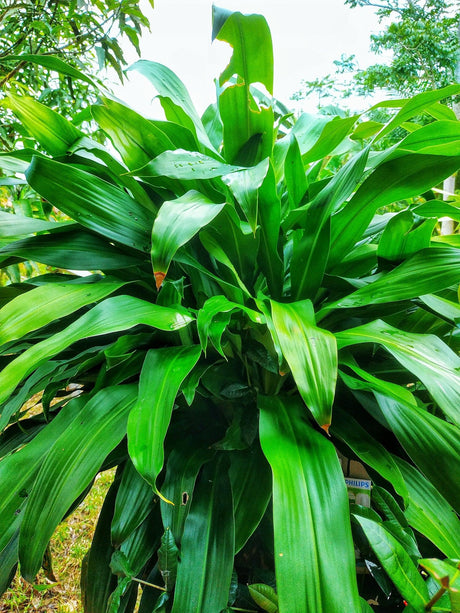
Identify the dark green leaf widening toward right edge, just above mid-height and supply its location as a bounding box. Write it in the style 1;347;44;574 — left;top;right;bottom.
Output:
330;247;460;308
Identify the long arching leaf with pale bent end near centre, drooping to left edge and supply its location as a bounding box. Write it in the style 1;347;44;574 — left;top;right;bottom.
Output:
0;296;192;402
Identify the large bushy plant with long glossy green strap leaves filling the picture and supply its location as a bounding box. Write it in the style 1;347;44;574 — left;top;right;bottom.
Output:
0;7;460;613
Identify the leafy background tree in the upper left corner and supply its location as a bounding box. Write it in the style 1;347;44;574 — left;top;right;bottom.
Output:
0;0;153;148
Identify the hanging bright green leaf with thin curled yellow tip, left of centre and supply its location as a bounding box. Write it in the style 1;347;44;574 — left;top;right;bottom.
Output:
128;346;201;502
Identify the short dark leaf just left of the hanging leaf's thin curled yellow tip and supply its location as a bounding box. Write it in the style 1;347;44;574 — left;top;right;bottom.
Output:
111;461;156;547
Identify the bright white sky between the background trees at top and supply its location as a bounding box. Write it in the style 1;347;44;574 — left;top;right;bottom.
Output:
115;0;380;117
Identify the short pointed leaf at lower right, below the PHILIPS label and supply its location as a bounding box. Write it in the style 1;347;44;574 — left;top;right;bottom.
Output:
354;515;429;613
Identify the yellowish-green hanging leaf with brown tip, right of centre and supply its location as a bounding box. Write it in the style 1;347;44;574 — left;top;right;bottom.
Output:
271;300;337;431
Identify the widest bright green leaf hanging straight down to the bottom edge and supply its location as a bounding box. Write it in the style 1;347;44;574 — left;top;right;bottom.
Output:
259;396;360;613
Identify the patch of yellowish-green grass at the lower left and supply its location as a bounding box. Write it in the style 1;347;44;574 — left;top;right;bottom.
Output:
0;471;114;613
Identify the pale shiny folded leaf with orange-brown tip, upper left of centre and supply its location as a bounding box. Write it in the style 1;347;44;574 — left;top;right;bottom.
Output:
151;190;225;289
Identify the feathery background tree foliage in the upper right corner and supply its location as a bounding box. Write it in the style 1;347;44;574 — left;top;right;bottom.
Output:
294;0;460;101
